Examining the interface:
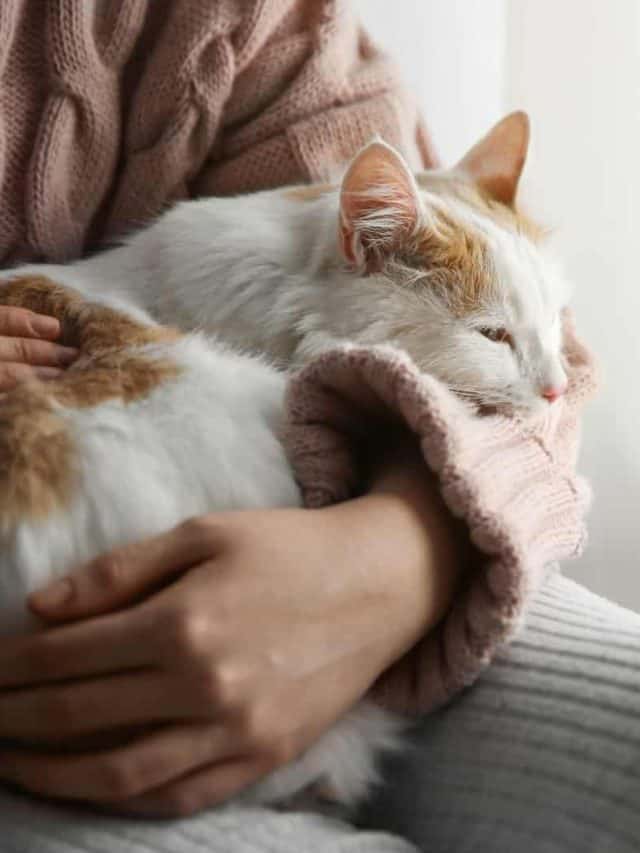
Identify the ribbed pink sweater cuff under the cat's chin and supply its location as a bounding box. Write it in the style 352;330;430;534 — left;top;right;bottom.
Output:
287;317;595;713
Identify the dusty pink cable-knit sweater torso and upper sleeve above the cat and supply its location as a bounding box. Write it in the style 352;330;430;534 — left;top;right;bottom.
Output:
0;0;433;264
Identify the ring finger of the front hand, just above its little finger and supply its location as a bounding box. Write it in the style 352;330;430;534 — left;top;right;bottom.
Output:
0;725;235;803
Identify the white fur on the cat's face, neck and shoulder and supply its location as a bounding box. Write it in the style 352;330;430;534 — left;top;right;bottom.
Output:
4;159;569;411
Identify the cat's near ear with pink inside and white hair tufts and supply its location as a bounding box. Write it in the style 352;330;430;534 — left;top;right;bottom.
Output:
339;140;421;272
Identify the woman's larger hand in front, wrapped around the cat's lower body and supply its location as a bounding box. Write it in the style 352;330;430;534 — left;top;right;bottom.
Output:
0;442;457;815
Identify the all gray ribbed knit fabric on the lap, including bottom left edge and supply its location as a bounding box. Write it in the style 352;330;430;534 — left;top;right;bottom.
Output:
0;577;640;853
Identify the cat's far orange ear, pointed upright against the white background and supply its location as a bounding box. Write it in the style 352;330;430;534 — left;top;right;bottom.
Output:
456;112;529;207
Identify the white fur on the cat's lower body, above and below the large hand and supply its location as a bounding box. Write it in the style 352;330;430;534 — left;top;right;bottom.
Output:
0;333;403;806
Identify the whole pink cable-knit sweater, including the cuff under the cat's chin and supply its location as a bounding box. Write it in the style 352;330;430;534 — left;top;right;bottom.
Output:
0;0;593;710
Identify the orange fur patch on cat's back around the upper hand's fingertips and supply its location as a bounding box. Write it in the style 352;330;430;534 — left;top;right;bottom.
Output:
0;276;179;523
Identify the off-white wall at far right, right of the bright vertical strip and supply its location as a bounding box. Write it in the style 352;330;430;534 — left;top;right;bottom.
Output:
506;0;640;609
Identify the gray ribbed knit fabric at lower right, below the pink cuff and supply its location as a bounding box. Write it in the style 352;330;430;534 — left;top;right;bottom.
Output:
366;576;640;853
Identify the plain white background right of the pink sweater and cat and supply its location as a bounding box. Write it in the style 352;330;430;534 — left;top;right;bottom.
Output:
354;0;640;610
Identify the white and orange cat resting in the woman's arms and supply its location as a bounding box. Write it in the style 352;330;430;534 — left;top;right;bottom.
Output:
0;113;567;804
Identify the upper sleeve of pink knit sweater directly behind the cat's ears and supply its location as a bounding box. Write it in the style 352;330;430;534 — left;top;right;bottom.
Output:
193;0;437;195
